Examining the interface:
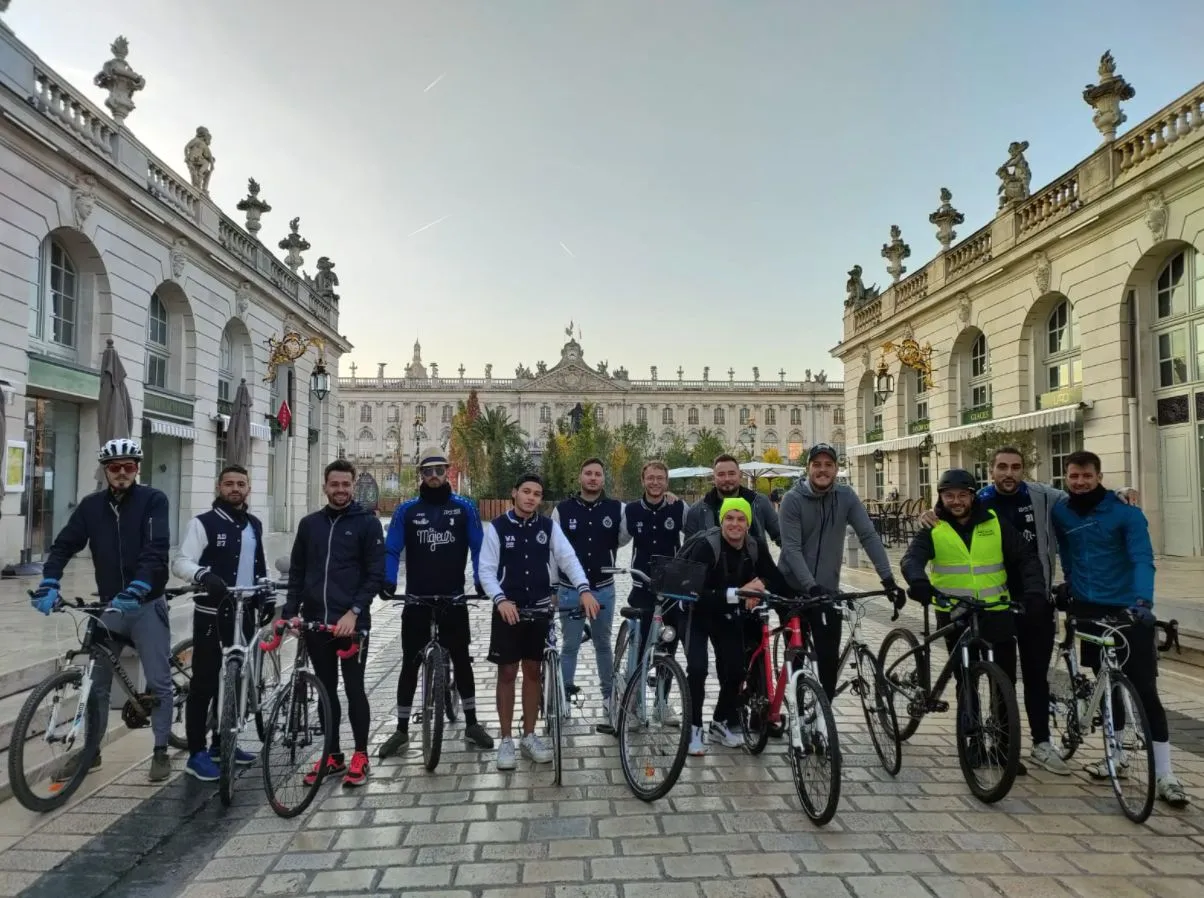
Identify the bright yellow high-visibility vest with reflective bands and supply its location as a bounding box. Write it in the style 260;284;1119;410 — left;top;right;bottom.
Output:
928;512;1011;612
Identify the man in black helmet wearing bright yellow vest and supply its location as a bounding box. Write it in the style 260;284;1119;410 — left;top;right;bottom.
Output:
899;468;1045;760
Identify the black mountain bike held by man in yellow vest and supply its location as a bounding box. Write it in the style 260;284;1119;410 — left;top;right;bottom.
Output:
878;595;1020;804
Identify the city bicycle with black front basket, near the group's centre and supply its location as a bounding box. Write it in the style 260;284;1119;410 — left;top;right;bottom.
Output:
600;556;706;802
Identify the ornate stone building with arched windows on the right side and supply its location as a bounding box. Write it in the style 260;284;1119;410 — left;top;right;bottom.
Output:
833;54;1204;555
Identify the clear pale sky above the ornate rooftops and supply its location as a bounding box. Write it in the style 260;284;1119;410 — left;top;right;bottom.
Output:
6;0;1204;378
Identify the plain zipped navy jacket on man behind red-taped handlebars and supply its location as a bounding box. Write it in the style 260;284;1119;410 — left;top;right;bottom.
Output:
284;502;384;630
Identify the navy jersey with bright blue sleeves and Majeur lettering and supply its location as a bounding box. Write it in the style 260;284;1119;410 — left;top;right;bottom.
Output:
384;486;484;596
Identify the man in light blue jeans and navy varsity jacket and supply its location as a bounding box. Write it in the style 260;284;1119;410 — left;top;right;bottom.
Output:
551;459;626;714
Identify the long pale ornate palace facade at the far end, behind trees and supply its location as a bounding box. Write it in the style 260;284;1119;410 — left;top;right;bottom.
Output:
337;326;844;488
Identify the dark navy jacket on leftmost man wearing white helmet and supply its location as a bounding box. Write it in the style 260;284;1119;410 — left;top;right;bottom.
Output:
42;483;171;602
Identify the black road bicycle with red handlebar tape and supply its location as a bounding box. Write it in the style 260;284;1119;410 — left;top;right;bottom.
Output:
259;620;367;819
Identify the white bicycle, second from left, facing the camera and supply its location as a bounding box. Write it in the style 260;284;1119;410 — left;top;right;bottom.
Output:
213;579;288;807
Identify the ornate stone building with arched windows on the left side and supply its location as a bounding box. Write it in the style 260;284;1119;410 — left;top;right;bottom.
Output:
0;12;349;565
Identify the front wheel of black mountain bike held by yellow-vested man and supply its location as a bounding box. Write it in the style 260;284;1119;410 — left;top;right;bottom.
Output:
957;661;1020;804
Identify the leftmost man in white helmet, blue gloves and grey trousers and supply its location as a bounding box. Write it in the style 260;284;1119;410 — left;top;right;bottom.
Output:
31;438;172;782
